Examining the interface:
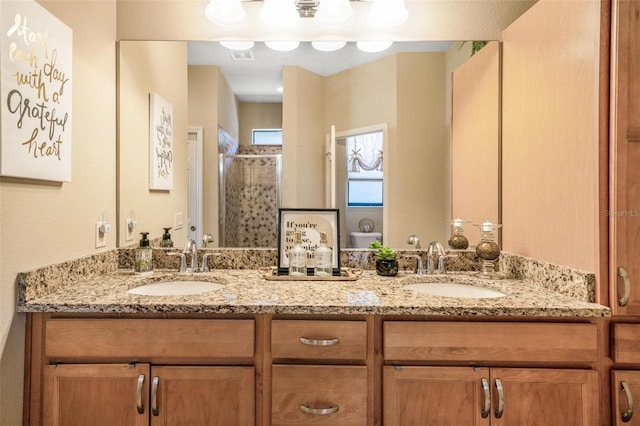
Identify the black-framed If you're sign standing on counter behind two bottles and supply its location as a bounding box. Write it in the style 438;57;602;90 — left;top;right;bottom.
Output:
278;209;340;276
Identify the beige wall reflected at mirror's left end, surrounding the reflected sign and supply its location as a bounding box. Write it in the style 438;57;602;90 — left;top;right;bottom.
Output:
118;41;188;246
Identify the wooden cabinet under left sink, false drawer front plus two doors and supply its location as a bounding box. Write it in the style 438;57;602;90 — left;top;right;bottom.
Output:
25;315;256;426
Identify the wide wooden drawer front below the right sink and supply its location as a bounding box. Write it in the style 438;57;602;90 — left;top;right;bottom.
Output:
383;321;598;364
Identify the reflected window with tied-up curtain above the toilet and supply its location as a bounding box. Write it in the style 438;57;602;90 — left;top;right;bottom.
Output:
347;132;383;207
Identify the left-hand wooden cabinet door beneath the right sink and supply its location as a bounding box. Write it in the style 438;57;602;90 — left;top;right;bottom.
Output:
383;367;491;426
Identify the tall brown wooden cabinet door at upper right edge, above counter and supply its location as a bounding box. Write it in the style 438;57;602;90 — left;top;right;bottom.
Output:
607;0;640;315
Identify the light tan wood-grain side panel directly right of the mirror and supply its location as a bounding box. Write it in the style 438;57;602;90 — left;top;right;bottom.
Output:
502;0;606;273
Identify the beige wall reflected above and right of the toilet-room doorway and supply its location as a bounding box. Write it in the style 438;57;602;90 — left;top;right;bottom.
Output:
325;53;448;248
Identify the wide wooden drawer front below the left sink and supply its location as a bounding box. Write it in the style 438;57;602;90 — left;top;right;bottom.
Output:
45;319;254;360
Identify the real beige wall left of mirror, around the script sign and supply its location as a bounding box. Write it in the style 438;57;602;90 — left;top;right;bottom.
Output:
0;1;116;425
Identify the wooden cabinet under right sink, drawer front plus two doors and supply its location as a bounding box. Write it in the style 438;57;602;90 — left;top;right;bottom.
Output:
383;321;600;426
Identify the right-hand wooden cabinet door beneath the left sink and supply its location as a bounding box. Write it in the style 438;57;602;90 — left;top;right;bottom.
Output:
150;366;255;426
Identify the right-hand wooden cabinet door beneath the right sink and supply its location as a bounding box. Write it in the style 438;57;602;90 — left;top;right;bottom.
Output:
491;368;601;426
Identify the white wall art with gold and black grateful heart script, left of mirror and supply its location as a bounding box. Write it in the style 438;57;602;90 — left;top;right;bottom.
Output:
0;0;73;182
